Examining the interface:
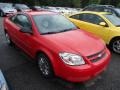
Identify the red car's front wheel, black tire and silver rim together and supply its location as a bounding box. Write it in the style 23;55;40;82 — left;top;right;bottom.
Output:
38;54;54;78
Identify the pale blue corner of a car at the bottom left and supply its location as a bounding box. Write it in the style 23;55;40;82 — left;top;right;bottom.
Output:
0;70;9;90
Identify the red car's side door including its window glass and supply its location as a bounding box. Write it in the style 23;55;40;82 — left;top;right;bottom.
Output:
9;14;36;56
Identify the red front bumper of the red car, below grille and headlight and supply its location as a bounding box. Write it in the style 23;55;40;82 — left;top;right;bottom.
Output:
57;49;111;82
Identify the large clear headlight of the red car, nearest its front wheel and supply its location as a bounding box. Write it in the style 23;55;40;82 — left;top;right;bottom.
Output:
59;53;85;65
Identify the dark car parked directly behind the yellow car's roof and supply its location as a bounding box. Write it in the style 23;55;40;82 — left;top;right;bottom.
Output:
83;5;120;17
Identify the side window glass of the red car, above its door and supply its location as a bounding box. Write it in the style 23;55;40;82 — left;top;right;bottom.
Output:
11;14;31;27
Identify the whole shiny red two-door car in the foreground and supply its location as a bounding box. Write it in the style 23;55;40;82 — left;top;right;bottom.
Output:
4;11;111;82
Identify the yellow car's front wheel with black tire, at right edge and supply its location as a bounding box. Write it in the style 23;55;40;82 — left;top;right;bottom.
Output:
110;38;120;54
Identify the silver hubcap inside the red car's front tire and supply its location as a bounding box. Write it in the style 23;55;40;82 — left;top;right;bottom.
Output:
38;57;49;76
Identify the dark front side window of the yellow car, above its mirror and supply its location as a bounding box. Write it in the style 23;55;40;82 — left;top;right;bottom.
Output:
82;14;105;25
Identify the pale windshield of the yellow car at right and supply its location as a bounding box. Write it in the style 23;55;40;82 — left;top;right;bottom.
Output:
104;14;120;26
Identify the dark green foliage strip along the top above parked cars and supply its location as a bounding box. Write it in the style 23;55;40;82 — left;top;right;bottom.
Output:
0;0;120;7
